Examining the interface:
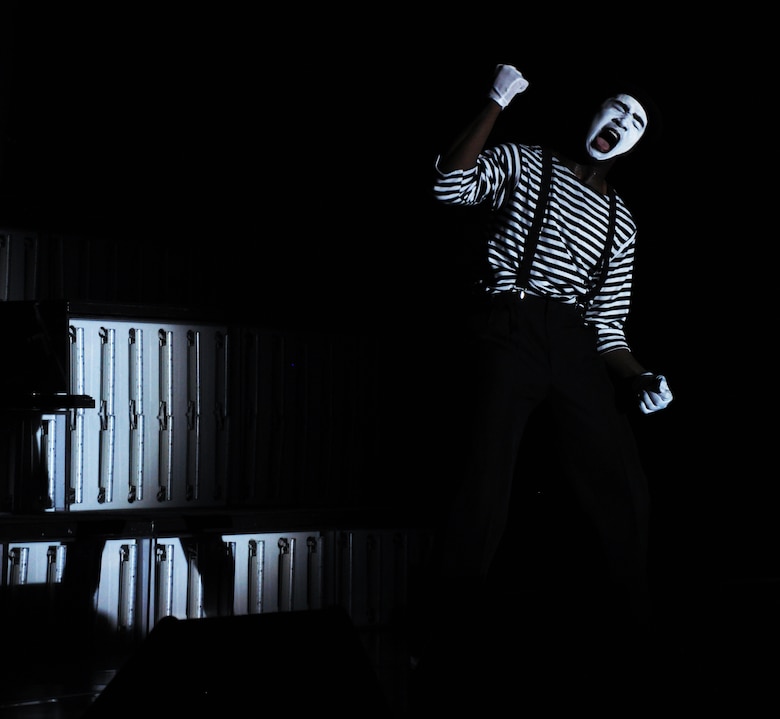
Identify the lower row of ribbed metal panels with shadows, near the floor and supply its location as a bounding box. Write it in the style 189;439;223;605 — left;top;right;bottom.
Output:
1;517;421;649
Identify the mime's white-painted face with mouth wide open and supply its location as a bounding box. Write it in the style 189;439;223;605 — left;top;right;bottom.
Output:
585;94;647;160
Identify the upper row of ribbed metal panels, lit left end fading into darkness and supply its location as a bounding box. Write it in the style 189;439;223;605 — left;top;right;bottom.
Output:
0;301;382;512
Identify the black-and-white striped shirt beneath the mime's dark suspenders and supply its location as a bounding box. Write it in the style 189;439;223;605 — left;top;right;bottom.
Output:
434;143;637;352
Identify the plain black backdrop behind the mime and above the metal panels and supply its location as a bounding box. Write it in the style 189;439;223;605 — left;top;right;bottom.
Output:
0;0;778;576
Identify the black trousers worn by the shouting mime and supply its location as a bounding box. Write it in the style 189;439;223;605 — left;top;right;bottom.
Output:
429;293;649;632
